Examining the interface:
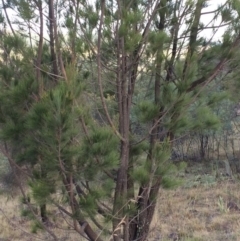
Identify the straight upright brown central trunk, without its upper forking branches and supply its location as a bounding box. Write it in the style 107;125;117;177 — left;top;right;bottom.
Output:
113;38;130;241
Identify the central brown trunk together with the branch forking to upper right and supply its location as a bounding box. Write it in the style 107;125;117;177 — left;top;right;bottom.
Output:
113;1;164;241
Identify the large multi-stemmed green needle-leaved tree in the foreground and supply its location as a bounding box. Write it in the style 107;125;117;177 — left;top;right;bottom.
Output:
0;0;240;241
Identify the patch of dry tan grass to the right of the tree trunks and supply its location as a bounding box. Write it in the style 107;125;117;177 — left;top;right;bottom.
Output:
149;167;240;241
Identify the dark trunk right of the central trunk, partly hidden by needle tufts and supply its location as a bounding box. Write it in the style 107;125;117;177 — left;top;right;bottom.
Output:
130;0;167;241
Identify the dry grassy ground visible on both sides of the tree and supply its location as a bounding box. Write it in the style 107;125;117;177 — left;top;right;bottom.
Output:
0;163;240;241
